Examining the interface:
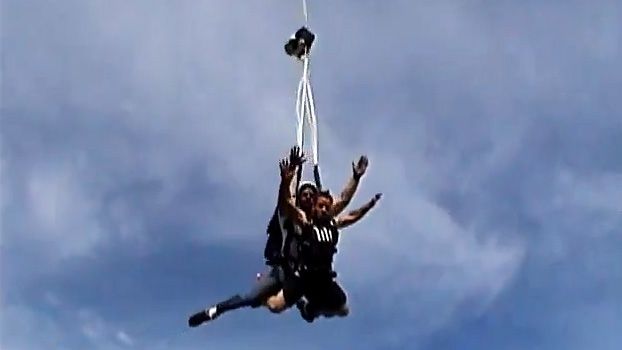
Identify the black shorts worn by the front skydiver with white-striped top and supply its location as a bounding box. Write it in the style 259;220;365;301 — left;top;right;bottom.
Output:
283;274;347;310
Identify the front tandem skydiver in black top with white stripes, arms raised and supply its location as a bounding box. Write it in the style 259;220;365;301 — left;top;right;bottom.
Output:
267;153;381;322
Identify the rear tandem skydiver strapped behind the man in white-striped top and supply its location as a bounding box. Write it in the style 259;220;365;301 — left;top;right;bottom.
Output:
188;146;369;327
